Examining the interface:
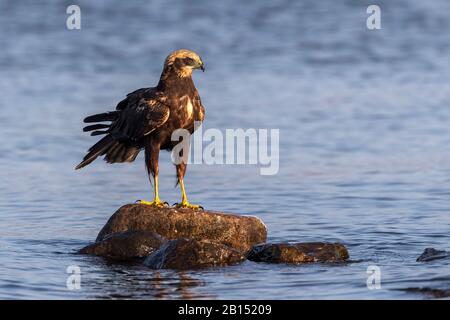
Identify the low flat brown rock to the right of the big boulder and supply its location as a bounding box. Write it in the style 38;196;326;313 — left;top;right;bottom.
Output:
247;242;349;263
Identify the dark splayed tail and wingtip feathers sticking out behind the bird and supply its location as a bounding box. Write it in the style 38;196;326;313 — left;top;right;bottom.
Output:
75;111;140;170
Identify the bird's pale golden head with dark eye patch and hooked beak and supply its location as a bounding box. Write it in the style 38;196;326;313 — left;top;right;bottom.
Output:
164;49;205;78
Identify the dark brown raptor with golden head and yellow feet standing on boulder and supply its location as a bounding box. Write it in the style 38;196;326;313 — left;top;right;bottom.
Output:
76;49;205;209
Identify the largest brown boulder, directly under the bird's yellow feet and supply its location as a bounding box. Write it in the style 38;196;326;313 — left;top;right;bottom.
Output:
96;204;267;252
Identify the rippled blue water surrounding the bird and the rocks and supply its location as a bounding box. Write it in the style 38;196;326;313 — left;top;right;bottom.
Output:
0;0;450;299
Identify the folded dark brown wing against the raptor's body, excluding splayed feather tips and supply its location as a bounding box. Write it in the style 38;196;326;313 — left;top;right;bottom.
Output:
110;94;170;141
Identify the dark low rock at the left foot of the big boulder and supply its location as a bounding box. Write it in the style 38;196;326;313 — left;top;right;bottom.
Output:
79;231;167;261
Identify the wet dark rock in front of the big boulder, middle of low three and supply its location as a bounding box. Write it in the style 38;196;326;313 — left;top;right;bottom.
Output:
144;238;245;270
